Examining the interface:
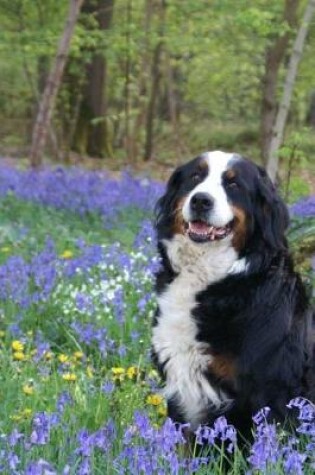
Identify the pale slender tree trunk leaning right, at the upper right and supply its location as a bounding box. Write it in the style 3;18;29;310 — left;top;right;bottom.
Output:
267;0;315;182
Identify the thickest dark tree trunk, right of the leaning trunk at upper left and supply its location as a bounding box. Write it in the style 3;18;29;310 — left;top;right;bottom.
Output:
74;0;114;157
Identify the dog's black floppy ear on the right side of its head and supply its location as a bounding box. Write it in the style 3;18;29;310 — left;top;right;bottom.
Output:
256;167;289;250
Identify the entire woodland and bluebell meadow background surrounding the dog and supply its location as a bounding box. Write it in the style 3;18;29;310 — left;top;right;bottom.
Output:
0;0;315;475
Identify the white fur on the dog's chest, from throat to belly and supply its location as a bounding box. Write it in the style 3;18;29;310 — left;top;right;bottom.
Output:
152;236;237;429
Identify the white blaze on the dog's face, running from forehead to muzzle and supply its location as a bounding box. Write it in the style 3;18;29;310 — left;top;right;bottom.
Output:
183;151;235;227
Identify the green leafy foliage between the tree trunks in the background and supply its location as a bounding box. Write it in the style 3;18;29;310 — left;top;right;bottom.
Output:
0;0;315;166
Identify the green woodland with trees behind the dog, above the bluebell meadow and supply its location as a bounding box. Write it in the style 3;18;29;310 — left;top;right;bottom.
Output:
0;0;315;197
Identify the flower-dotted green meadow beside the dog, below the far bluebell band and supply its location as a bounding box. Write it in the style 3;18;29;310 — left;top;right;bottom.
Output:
0;170;313;475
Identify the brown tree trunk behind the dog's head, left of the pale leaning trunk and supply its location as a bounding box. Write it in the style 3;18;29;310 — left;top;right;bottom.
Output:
260;0;299;165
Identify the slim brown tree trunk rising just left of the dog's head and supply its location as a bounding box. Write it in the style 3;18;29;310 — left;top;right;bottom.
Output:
144;0;166;161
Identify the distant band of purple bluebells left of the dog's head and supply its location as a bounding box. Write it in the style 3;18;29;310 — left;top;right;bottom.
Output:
0;166;164;227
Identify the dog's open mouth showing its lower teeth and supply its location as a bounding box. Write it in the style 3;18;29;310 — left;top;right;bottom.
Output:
186;221;233;242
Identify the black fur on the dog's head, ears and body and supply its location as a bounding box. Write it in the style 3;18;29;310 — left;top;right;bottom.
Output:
154;152;315;436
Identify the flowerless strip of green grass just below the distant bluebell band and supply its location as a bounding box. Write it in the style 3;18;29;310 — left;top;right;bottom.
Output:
0;195;150;263
